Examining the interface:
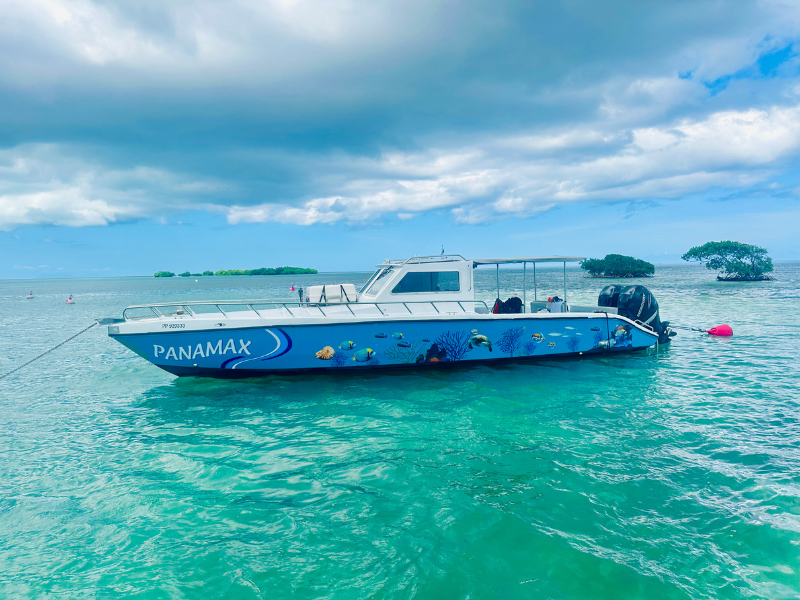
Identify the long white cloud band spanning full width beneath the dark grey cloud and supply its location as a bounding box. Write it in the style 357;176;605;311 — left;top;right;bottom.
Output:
6;105;800;230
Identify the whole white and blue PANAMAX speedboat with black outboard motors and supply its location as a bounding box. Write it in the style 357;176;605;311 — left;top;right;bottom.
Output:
108;255;671;377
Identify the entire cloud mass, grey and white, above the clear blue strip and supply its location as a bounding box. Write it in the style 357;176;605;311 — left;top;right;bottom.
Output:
0;0;800;228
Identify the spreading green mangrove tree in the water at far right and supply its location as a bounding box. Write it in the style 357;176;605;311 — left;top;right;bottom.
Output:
681;241;773;281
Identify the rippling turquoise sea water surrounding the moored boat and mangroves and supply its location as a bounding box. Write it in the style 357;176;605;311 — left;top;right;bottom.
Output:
0;263;800;599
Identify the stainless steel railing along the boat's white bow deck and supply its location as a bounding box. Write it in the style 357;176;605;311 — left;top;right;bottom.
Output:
122;300;491;321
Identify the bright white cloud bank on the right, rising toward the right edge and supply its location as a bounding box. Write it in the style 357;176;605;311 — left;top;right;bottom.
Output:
219;105;800;225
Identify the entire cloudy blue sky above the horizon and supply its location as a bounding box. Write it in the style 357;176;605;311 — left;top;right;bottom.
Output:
0;0;800;278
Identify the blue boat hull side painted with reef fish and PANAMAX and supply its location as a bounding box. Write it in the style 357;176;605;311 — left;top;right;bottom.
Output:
109;315;657;378
